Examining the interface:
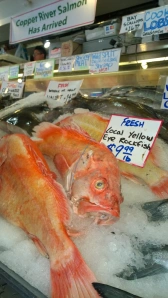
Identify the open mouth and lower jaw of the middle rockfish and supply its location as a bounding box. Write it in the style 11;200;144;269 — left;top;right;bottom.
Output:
71;198;120;225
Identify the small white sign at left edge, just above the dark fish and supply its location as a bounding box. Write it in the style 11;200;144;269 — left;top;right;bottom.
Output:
1;81;24;98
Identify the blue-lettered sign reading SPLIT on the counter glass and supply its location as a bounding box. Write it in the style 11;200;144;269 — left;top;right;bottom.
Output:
89;49;121;73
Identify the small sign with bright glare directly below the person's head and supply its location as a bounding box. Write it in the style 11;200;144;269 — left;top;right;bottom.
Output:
34;59;55;79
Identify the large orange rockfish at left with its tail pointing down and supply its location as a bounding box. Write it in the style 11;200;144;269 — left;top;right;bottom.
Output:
0;134;98;298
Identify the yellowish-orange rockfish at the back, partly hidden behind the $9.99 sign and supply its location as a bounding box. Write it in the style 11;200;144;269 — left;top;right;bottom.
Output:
55;112;168;198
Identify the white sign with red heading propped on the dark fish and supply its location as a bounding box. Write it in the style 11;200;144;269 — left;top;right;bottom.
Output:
45;80;83;103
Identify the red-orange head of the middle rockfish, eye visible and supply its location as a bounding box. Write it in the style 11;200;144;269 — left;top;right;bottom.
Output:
71;145;123;225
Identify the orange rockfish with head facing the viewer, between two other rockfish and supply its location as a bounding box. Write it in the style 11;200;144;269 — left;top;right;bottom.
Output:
33;122;123;224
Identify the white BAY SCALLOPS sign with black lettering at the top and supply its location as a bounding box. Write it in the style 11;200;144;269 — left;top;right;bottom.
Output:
120;12;145;34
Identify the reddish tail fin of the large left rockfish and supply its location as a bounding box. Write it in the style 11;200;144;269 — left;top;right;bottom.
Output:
50;246;100;298
